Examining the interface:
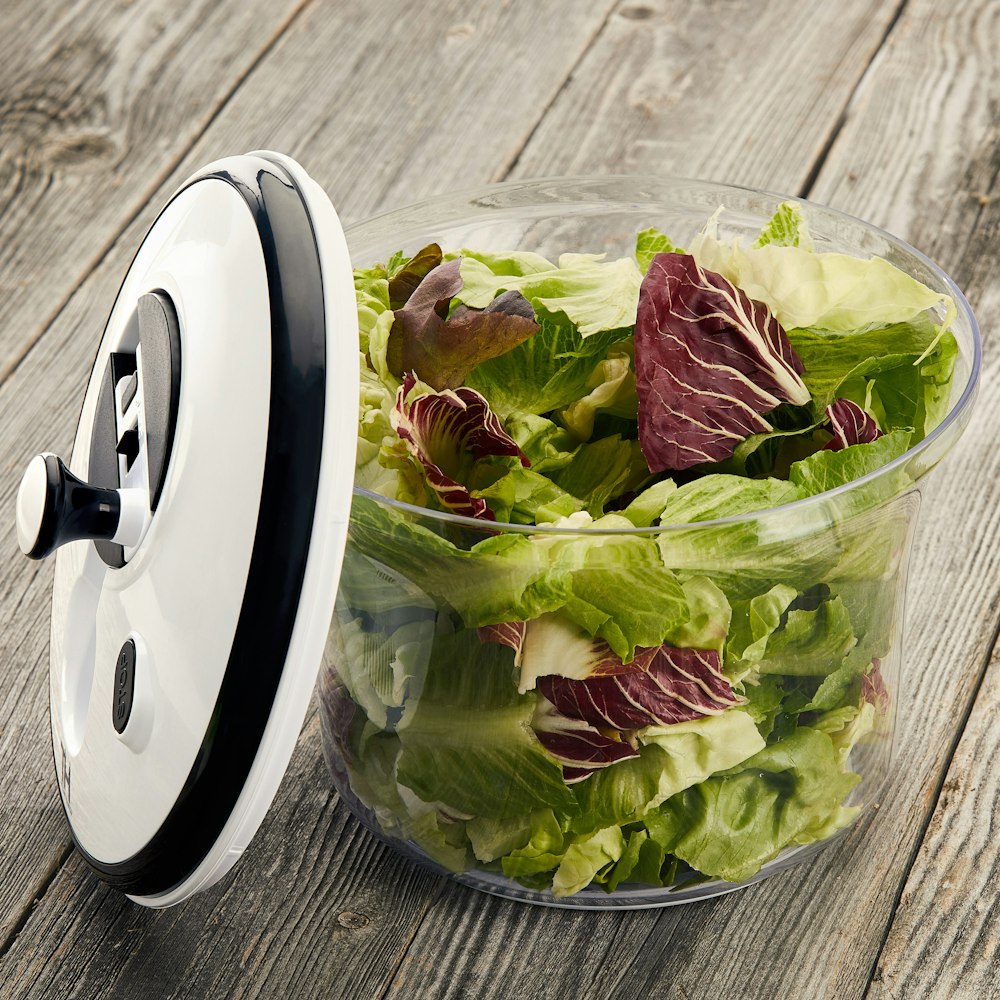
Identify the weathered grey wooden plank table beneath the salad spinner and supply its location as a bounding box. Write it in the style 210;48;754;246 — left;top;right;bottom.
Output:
0;0;1000;1000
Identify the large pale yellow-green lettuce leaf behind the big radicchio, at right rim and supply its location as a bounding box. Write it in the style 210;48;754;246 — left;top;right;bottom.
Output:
691;225;955;333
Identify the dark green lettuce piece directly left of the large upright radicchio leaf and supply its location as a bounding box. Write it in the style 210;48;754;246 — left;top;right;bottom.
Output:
466;314;631;419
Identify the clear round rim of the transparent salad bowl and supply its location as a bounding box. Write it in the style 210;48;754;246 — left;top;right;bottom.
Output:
345;174;983;536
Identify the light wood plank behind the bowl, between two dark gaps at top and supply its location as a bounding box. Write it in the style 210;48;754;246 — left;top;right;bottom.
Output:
513;0;898;192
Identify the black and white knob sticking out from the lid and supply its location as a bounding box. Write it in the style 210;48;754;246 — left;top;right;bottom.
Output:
17;454;148;559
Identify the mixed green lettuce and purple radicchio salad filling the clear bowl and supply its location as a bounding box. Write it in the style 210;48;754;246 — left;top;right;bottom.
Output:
321;202;957;896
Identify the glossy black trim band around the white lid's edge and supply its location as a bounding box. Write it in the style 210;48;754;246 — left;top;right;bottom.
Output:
67;156;327;896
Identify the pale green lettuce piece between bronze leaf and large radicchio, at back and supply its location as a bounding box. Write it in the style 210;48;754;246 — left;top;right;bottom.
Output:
456;250;642;336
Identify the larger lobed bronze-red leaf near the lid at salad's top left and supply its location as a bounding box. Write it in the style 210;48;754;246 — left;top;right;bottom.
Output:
386;259;538;389
